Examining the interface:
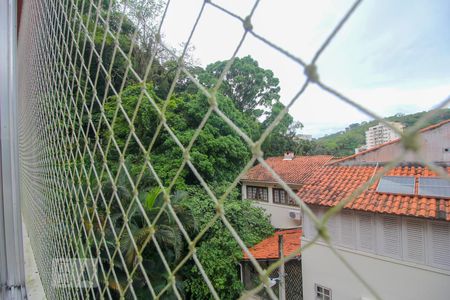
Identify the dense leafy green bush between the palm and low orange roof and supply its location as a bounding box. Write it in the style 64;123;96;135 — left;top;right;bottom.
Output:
182;187;274;299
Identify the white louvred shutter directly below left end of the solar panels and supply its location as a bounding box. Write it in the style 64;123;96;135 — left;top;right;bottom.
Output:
379;216;402;258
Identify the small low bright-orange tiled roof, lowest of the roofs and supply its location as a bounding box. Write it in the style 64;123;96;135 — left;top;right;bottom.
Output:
243;229;302;260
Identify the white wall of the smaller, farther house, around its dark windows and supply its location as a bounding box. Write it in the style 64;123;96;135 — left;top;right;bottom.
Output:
242;183;301;229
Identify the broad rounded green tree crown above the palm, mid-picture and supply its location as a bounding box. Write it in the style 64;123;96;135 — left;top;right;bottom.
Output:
97;84;260;189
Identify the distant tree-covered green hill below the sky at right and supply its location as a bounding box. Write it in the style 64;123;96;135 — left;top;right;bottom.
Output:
314;108;450;157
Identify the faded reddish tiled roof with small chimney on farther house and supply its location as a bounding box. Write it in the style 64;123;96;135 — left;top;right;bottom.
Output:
242;155;333;184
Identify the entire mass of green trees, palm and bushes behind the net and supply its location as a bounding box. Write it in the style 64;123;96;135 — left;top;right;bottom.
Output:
72;0;309;299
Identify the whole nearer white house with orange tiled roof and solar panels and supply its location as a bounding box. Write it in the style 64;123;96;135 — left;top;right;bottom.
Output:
297;120;450;300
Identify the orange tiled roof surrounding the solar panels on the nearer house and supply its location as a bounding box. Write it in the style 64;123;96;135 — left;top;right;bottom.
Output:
298;165;450;221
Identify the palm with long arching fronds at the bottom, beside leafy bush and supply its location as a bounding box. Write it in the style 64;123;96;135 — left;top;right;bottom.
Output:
83;166;197;299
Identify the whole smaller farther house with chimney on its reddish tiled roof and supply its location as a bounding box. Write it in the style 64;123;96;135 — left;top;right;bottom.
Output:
241;152;332;229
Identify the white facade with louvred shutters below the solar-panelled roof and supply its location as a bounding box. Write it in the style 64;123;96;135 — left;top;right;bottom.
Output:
302;207;450;300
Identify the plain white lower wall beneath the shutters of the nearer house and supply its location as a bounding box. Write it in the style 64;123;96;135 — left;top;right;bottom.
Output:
302;241;450;300
